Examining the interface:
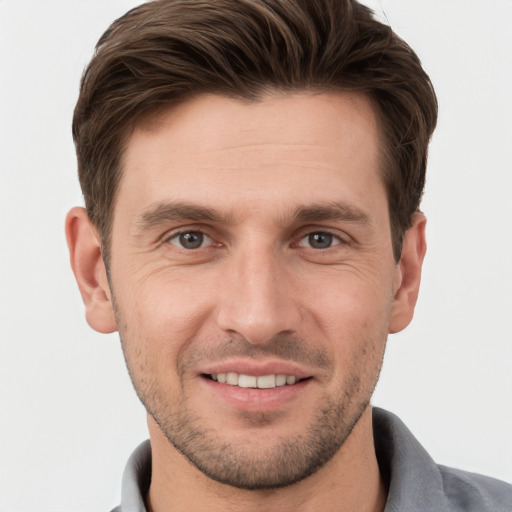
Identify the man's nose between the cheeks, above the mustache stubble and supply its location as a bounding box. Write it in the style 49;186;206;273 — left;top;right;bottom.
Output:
217;241;301;344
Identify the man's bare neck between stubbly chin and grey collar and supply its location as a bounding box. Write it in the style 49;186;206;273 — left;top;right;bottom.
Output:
147;406;386;512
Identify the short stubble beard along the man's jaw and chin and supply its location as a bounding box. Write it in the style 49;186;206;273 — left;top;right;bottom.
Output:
122;330;383;490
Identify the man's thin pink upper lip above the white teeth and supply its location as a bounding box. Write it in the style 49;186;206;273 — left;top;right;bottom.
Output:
200;360;312;379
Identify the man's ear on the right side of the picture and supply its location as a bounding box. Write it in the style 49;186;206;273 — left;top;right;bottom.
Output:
389;213;427;334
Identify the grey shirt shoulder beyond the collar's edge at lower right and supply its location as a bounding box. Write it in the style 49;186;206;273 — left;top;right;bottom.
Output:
438;466;512;512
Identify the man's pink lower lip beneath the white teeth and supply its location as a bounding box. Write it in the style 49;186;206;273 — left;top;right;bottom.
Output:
201;377;312;412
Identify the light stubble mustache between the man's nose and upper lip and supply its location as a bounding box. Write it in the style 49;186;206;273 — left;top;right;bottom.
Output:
178;334;333;373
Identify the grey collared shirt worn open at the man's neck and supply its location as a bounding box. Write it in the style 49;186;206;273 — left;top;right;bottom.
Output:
112;408;512;512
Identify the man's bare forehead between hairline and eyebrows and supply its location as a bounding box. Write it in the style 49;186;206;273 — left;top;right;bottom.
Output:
118;93;383;226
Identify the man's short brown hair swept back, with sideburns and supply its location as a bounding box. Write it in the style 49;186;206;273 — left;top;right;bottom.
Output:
73;0;437;263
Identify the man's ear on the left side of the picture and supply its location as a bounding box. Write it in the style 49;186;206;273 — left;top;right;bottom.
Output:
66;207;117;333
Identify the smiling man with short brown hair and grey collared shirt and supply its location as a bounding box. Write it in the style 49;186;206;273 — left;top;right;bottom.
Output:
66;0;512;512
